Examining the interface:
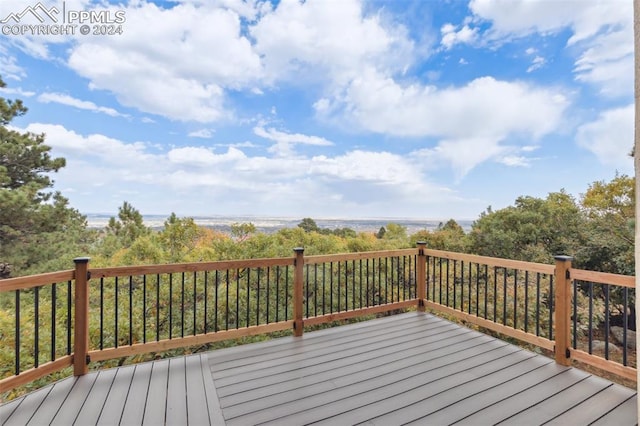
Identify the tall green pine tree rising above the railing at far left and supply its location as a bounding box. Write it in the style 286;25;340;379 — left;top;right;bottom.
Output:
0;78;90;275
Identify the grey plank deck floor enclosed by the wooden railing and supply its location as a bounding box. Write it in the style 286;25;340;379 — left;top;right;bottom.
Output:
0;313;637;425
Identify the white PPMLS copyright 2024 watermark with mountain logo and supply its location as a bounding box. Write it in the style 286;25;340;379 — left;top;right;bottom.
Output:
0;2;126;36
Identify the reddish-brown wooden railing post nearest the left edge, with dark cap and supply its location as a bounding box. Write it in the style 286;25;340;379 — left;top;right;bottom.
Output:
73;257;89;376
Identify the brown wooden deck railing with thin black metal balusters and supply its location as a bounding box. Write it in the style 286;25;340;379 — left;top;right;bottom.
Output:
0;243;636;398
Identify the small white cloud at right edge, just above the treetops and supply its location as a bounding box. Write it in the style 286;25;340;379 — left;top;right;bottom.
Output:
576;104;634;173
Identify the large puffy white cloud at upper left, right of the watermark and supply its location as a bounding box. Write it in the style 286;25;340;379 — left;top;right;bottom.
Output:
68;2;262;122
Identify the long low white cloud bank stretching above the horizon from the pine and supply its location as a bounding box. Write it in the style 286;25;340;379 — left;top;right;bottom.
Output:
16;123;468;216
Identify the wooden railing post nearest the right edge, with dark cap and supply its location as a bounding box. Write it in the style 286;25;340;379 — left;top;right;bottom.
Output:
554;256;573;365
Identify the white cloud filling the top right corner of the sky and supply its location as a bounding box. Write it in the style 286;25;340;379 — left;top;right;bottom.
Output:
469;0;634;96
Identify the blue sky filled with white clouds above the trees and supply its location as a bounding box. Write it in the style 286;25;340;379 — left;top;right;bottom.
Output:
0;0;634;219
